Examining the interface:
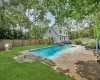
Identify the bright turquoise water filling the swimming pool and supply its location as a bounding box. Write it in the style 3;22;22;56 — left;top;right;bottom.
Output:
30;45;71;59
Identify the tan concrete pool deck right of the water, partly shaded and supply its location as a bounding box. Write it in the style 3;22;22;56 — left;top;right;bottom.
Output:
53;45;100;80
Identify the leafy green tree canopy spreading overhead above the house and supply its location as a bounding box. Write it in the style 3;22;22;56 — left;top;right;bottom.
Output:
0;0;100;38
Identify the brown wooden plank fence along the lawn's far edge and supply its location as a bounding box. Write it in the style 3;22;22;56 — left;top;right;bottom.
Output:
0;40;53;50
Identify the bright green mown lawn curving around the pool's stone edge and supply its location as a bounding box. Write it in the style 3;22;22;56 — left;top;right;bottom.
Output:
0;45;73;80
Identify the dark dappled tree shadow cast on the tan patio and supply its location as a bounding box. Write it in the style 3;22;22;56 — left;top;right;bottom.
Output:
76;60;100;80
